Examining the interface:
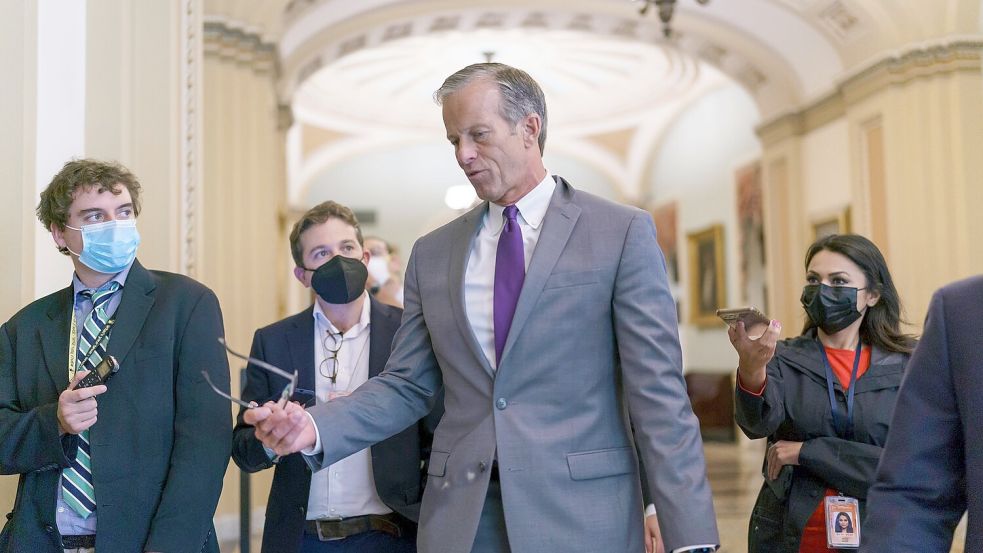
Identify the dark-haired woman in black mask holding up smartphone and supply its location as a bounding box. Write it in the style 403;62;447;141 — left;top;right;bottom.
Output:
729;234;914;553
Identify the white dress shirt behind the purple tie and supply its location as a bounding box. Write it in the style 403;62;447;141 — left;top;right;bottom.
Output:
464;175;556;368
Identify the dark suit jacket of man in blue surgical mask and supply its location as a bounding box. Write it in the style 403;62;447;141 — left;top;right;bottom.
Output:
0;261;232;553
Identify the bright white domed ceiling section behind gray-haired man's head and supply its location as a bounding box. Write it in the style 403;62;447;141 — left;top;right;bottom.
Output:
293;29;723;137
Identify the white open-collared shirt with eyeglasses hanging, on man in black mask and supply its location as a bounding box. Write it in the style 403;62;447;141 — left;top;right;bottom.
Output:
307;297;392;520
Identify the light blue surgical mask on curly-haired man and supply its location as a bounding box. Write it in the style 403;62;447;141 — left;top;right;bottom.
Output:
65;219;140;274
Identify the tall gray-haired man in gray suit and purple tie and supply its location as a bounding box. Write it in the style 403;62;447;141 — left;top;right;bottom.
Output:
245;63;719;553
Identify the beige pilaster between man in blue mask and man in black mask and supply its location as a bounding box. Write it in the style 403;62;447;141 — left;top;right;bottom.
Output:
197;23;289;539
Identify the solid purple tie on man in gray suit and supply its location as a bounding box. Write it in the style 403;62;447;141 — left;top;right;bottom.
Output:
494;205;526;365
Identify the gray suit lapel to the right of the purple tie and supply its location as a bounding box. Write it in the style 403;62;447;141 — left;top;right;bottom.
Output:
499;177;580;366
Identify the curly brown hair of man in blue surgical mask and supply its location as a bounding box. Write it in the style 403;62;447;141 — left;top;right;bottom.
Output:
37;159;140;230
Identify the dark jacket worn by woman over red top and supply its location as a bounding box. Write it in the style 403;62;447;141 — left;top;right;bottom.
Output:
735;330;908;553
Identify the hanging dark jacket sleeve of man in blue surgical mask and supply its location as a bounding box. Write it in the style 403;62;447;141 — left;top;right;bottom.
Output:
144;290;232;552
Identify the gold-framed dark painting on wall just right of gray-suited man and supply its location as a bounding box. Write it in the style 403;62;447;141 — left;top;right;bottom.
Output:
686;225;727;326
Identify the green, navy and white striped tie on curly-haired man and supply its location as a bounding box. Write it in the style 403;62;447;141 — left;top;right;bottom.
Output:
61;281;119;519
